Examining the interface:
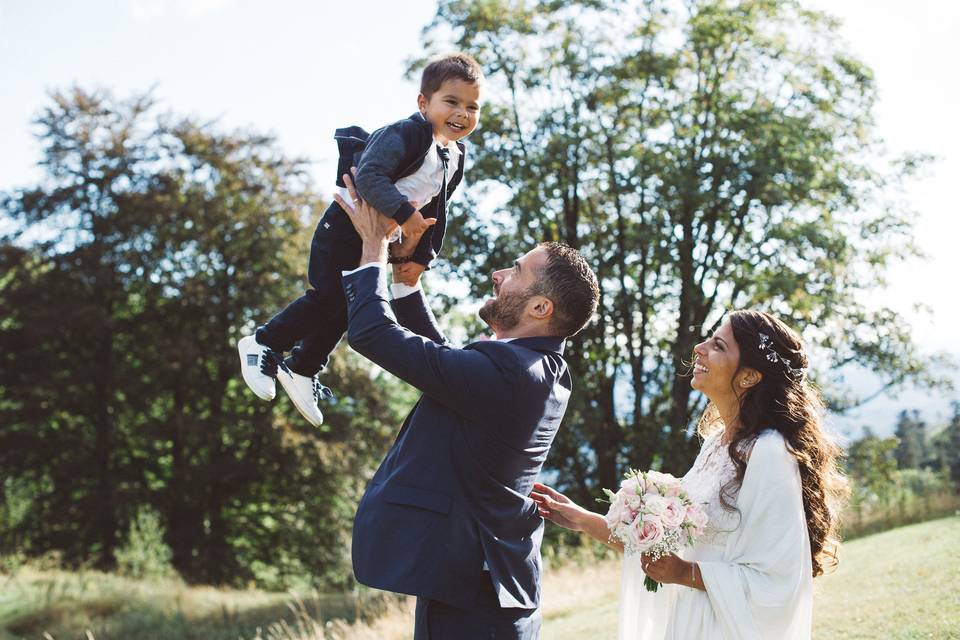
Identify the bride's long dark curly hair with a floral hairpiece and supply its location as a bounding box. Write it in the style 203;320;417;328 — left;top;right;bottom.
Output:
698;311;847;577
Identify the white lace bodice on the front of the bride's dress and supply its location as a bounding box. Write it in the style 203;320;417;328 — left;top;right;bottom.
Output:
683;433;740;546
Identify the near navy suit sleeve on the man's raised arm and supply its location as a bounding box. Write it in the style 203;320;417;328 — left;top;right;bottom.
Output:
343;269;522;416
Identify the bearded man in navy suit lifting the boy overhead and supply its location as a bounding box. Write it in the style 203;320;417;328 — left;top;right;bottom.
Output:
338;171;599;640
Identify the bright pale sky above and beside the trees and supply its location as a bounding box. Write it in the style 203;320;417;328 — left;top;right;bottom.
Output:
0;0;960;432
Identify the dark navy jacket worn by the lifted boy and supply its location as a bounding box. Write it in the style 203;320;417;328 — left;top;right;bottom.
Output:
334;112;467;266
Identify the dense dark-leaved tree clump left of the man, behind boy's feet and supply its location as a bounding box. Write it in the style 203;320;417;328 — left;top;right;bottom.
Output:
0;89;409;587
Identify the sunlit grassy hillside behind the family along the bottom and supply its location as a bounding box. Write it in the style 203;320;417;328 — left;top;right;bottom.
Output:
0;517;960;640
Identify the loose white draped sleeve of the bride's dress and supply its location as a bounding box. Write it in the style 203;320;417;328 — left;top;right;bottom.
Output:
698;432;812;639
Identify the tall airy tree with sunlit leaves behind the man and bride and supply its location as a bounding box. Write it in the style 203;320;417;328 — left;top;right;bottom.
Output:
416;0;940;498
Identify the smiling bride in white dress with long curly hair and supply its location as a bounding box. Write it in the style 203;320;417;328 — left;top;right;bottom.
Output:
531;311;845;640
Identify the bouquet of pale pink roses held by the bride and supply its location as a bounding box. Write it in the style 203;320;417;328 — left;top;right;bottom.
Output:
603;469;707;591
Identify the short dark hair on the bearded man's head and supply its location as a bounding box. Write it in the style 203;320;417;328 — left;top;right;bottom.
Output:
534;242;600;338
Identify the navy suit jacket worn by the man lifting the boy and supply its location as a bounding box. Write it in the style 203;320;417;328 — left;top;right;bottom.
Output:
343;268;571;609
